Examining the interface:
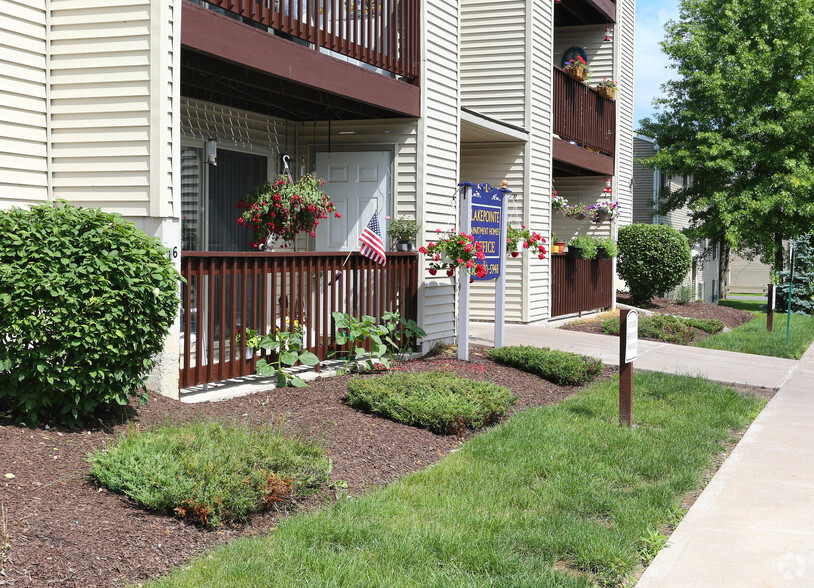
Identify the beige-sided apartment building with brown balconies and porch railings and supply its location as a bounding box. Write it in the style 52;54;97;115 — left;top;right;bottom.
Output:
0;0;635;396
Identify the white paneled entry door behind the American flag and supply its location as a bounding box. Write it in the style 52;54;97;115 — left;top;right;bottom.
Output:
315;151;390;251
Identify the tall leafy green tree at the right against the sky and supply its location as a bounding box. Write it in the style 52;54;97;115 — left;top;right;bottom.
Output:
639;0;814;271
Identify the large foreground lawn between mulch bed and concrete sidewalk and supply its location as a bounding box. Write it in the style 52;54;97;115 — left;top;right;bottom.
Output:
151;373;762;587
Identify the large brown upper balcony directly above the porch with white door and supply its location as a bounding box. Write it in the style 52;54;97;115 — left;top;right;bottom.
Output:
181;0;421;120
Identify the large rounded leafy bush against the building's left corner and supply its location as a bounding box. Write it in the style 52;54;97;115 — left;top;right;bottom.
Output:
0;204;179;426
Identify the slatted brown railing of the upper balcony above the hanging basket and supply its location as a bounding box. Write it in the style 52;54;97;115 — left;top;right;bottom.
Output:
201;0;421;81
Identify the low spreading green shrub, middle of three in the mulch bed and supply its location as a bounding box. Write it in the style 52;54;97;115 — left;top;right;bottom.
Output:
346;371;517;434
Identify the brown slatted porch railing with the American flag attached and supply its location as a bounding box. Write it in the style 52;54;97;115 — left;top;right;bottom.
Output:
180;251;418;388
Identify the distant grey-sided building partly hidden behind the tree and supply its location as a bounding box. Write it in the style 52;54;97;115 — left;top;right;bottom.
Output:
633;135;721;302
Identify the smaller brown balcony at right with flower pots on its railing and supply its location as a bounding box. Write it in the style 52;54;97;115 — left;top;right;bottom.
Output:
553;66;616;175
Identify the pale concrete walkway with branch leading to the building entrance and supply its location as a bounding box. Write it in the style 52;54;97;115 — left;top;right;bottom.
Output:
470;323;814;588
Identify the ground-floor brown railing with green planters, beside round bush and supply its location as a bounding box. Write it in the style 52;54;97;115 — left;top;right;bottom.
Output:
551;255;614;317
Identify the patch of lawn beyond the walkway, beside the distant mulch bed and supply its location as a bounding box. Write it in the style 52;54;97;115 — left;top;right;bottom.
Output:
694;300;814;359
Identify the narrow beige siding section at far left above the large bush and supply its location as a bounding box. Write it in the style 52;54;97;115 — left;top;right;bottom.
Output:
0;0;48;209
